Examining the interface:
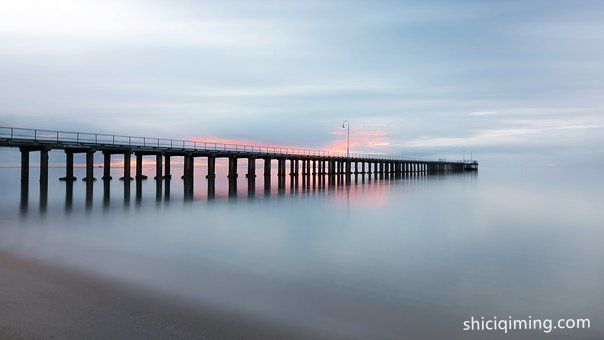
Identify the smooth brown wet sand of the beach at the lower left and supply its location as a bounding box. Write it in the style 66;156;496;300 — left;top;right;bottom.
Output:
0;252;333;339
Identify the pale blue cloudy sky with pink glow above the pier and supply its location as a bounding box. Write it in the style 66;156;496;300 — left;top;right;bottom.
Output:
0;0;604;167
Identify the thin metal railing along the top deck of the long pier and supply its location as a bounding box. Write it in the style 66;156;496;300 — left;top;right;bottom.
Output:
0;126;473;163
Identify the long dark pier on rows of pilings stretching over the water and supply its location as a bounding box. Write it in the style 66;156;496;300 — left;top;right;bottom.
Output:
0;127;478;195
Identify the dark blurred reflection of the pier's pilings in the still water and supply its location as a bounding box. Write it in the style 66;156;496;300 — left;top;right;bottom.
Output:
14;165;452;213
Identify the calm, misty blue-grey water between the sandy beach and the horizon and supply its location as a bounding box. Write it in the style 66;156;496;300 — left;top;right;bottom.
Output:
0;167;604;338
